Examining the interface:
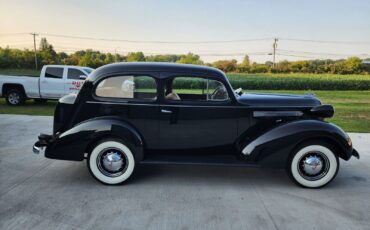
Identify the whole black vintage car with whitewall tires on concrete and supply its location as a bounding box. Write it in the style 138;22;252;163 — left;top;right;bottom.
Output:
33;63;359;188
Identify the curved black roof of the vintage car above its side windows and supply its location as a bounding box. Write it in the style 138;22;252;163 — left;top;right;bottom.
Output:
87;62;225;82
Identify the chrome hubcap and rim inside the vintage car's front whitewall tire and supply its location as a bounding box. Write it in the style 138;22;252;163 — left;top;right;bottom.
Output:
298;152;330;181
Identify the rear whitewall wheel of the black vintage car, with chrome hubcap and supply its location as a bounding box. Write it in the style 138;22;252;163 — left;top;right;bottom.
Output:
87;139;135;185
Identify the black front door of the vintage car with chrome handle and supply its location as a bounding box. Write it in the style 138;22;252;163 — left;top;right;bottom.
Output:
160;75;237;149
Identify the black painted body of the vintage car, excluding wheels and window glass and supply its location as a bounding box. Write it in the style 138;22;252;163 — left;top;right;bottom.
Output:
36;63;353;167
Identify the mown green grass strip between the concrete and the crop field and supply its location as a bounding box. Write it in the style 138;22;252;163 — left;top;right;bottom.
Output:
0;90;370;132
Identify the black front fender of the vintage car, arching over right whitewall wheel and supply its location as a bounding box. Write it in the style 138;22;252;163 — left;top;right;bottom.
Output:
241;120;353;167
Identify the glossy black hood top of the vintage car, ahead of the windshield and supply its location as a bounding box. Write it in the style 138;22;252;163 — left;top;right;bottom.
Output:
237;93;321;107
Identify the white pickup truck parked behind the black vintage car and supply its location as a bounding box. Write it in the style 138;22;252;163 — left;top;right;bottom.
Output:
0;65;93;105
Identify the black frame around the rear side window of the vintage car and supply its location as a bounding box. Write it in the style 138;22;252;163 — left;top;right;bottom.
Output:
92;72;159;104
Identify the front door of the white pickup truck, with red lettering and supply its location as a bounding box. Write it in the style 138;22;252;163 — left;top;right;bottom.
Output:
64;67;87;94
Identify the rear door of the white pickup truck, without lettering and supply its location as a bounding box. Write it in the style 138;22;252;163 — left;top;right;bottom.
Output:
40;66;65;98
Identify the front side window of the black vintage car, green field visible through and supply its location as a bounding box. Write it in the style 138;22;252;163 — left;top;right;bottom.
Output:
165;76;229;101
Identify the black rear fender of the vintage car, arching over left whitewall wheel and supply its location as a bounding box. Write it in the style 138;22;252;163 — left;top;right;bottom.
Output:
45;117;144;161
